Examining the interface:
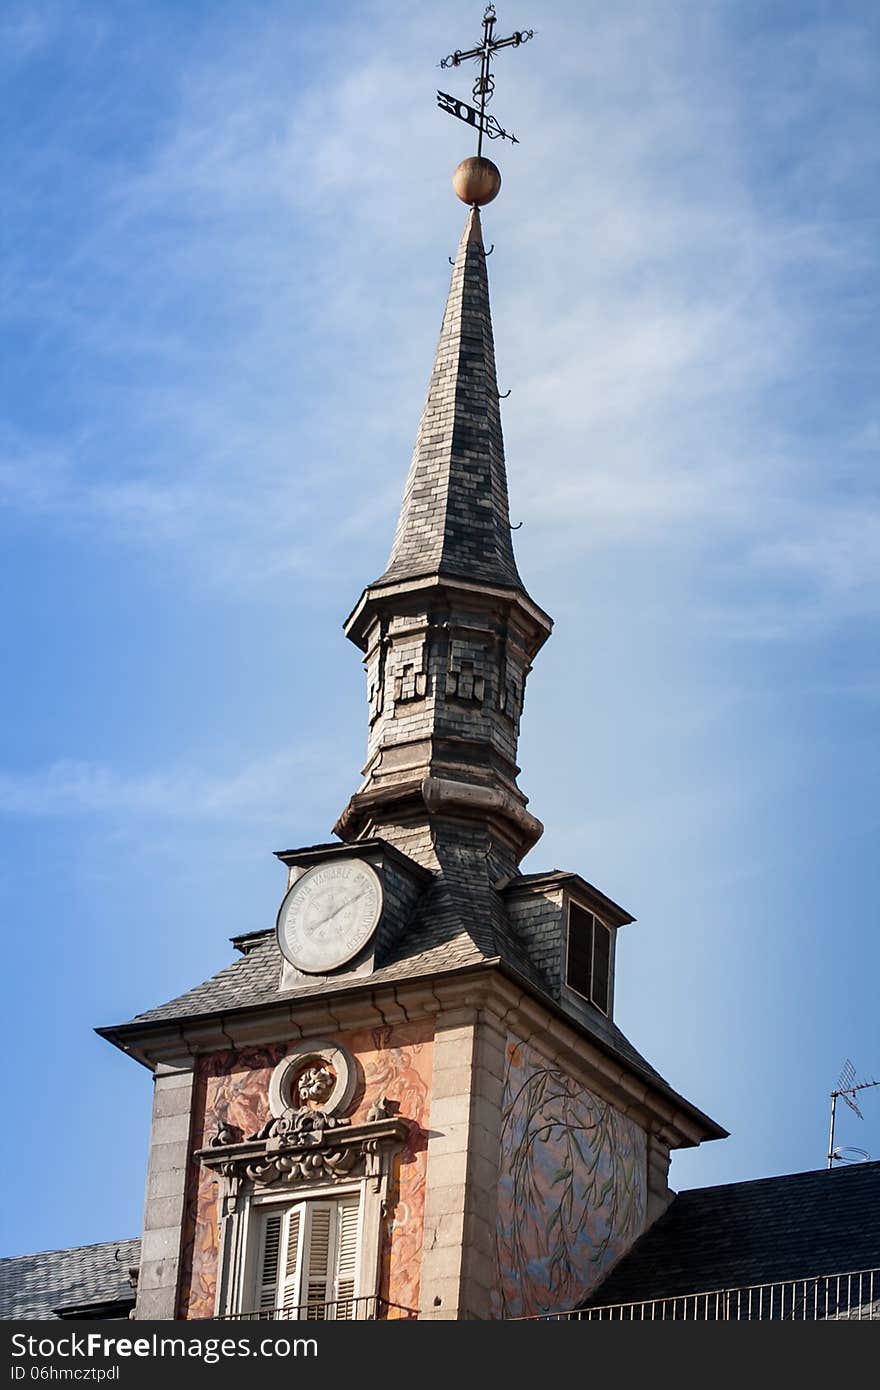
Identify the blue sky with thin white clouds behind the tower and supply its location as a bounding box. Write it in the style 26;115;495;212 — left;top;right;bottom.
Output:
0;0;880;1254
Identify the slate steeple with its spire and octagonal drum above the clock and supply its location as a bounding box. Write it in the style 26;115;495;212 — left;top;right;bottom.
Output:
335;198;552;872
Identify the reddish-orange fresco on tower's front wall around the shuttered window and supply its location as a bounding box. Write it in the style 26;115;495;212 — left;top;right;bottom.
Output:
179;1023;432;1318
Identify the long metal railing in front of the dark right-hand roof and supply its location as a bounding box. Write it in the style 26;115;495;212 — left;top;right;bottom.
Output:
514;1269;880;1322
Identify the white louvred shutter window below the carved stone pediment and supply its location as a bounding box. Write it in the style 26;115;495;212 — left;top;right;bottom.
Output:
254;1194;360;1321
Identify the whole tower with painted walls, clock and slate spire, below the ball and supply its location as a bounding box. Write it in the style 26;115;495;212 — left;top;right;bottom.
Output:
100;195;724;1319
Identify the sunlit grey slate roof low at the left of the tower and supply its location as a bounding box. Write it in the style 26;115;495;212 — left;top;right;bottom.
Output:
0;1240;140;1321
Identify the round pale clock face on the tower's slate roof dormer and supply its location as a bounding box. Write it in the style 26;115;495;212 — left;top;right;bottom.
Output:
278;859;382;974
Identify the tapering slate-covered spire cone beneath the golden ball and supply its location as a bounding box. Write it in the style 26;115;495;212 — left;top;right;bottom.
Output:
377;207;523;589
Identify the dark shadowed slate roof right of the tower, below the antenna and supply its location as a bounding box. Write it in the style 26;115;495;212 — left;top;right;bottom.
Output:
589;1162;880;1305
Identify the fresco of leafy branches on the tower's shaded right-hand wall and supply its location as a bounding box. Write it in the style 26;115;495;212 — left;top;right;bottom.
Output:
495;1036;646;1318
